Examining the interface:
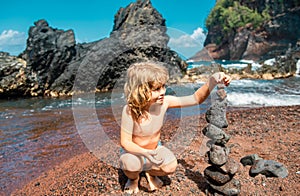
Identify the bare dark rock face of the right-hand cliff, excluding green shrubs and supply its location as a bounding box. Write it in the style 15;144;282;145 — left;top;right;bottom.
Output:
191;0;300;61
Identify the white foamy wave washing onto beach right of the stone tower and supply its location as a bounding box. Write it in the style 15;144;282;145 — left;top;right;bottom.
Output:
227;79;300;107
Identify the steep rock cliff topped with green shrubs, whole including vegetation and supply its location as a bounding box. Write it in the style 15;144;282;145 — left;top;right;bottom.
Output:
191;0;300;61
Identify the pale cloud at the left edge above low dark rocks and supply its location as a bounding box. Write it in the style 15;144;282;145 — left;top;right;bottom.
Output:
0;30;26;55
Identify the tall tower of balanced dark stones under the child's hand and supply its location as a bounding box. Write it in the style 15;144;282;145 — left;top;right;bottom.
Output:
203;85;241;195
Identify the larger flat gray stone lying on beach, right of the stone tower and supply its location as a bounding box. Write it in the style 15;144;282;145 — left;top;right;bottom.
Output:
249;159;288;178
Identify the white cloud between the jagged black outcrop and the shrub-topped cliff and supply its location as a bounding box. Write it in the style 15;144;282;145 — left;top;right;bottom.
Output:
169;27;206;57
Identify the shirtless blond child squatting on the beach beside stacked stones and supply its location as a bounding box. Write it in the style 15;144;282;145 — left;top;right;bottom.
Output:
120;62;231;193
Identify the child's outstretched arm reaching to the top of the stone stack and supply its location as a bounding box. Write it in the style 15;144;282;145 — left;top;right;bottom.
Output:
166;72;231;108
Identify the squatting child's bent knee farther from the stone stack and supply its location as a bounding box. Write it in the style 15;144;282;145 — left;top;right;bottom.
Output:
120;153;143;172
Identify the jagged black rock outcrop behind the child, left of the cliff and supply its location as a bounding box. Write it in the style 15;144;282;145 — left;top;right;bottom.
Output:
0;0;187;97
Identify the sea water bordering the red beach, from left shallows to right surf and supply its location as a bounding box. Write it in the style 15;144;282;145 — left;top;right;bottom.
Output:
0;70;300;195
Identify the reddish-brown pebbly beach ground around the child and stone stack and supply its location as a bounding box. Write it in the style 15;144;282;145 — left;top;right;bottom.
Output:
12;105;300;195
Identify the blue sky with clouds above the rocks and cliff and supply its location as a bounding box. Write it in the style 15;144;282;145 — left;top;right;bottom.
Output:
0;0;216;57
